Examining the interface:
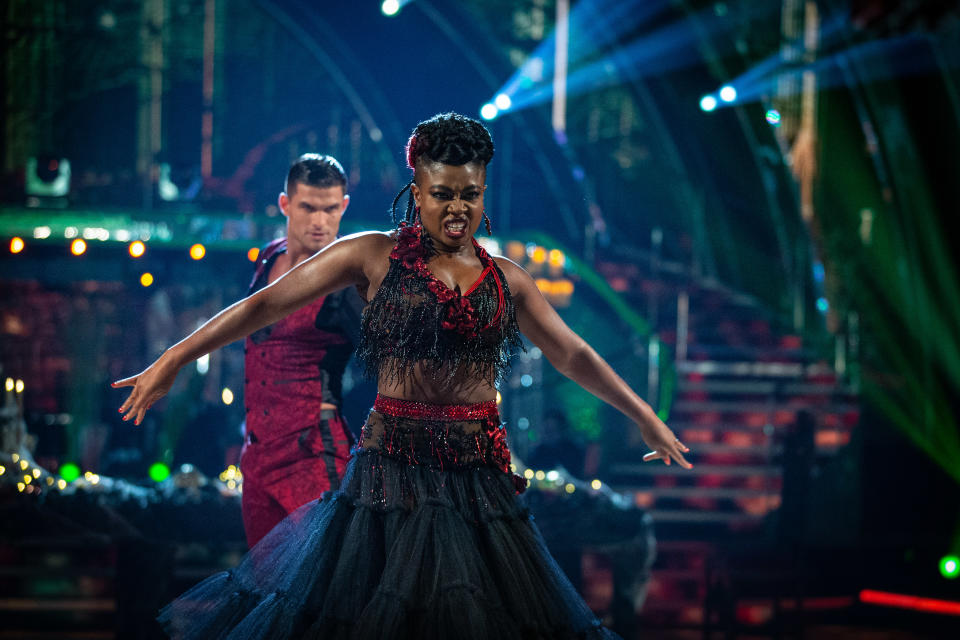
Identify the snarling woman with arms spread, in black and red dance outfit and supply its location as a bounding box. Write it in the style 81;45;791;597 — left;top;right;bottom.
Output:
114;114;690;640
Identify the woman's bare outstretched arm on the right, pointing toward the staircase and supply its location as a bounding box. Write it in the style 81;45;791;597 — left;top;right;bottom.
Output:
497;258;693;469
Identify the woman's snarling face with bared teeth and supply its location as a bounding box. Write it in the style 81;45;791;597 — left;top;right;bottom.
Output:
411;161;487;251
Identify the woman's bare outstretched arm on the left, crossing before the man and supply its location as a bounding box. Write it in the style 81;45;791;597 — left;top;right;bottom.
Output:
113;232;392;424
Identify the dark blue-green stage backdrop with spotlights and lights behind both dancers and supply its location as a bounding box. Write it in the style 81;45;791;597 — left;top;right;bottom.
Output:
0;0;960;638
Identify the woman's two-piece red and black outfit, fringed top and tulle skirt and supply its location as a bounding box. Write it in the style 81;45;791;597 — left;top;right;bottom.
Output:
160;227;617;640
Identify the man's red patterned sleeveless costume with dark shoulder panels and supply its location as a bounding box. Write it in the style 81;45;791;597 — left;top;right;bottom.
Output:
240;239;363;547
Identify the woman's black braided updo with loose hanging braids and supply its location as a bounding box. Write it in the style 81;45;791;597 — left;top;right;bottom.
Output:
390;113;493;234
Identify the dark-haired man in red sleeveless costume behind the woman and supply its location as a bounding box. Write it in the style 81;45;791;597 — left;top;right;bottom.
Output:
240;154;364;547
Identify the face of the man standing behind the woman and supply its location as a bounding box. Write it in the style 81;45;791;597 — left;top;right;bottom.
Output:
279;183;350;254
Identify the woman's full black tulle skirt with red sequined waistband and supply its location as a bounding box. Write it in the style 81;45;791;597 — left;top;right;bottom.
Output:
159;397;617;640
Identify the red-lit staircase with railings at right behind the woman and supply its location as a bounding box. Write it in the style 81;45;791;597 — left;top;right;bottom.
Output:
599;258;859;627
